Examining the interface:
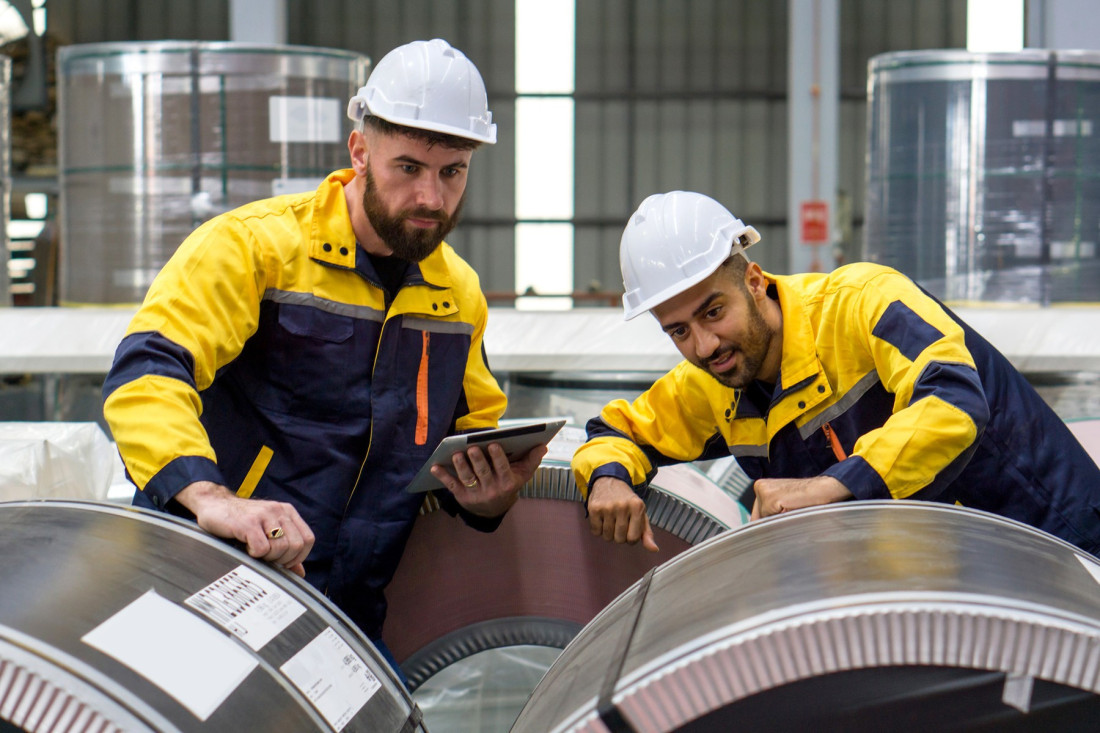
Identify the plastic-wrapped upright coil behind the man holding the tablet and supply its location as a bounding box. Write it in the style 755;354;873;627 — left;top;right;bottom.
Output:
57;41;369;304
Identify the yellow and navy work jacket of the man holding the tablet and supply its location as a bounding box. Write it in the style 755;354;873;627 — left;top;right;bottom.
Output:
103;169;505;638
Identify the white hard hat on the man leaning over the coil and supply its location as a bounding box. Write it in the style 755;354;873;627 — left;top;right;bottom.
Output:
619;190;760;320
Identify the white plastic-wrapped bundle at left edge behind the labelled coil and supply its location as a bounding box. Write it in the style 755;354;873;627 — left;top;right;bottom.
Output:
0;423;116;501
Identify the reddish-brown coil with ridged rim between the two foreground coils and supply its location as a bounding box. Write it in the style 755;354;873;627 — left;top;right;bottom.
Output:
384;440;748;690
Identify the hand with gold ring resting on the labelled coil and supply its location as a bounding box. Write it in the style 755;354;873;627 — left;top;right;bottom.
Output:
176;481;314;578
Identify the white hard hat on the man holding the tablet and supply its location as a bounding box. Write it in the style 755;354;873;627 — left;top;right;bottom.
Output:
348;39;496;144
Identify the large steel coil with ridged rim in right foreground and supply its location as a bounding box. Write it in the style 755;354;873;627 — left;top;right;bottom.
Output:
512;502;1100;733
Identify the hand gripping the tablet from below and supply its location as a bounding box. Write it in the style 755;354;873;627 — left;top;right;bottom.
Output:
431;442;547;517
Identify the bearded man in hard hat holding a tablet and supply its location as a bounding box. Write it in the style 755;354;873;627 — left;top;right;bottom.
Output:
103;39;546;663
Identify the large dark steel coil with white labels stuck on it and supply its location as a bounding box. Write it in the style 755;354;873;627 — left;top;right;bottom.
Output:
0;501;425;733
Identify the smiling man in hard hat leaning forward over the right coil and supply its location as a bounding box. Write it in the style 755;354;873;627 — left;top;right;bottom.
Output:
573;192;1100;555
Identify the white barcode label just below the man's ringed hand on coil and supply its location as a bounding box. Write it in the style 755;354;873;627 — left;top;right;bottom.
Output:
184;565;306;652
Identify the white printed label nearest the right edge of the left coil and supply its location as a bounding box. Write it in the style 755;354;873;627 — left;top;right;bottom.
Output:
279;626;382;731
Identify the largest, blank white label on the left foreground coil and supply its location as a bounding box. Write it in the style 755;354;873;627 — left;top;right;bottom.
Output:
81;590;256;720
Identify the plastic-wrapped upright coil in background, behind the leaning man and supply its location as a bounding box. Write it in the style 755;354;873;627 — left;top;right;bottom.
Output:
865;48;1100;305
